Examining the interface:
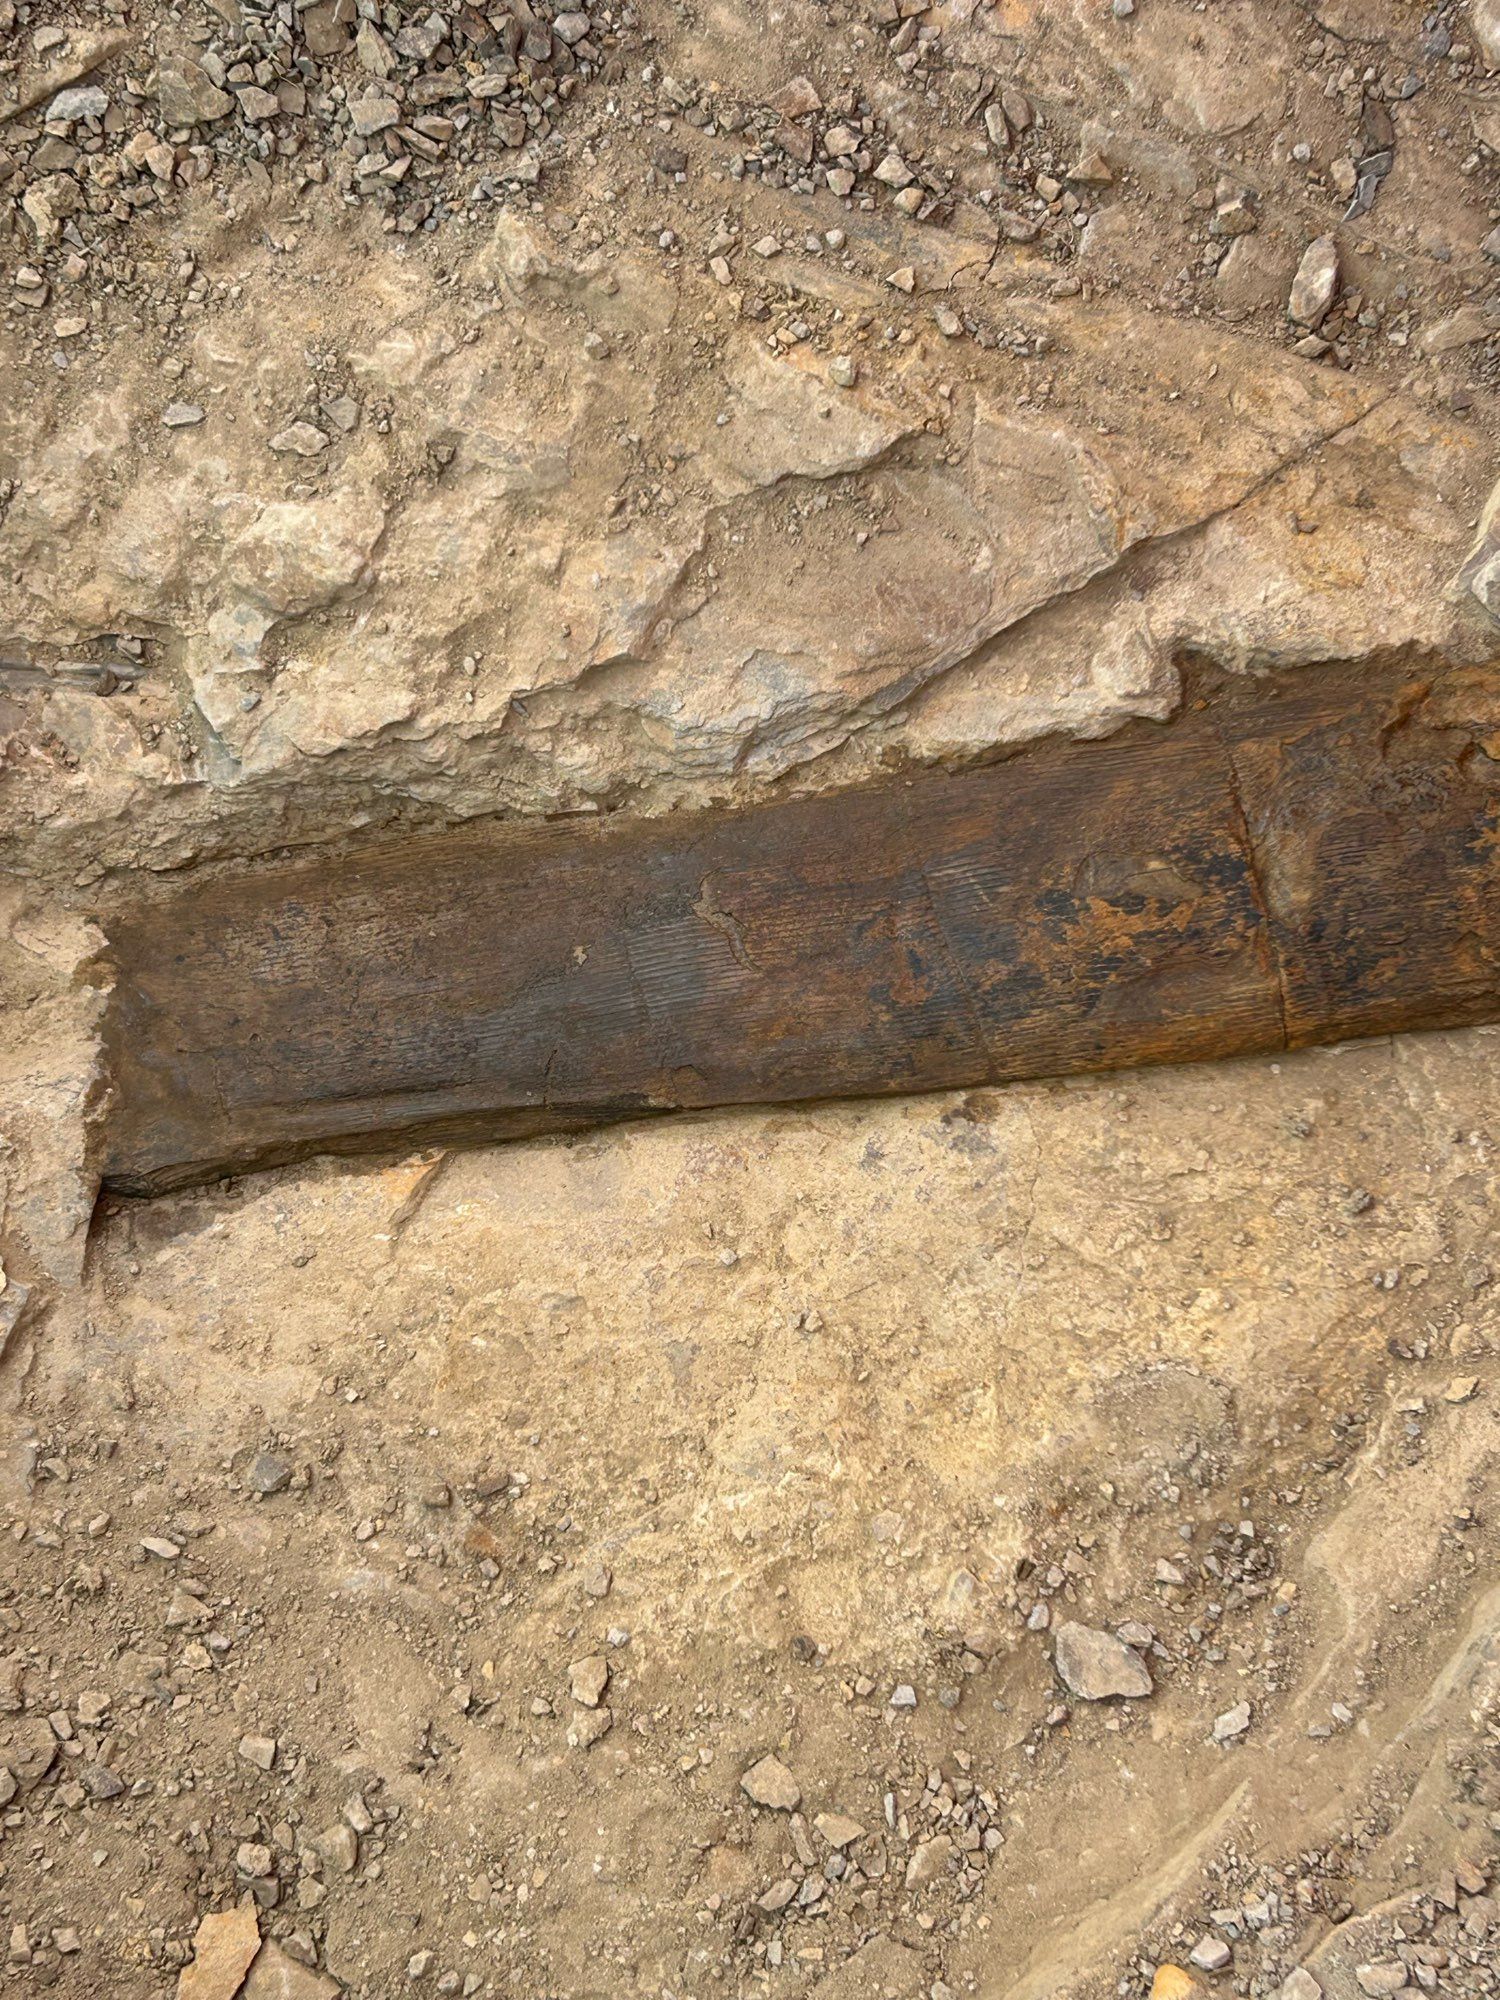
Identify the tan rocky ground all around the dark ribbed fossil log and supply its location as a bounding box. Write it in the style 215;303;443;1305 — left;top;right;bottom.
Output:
0;0;1500;2000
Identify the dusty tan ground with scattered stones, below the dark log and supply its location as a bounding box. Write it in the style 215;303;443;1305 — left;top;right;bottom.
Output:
2;1030;1500;2000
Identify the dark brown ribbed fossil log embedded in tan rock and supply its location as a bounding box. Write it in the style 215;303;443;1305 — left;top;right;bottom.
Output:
106;670;1500;1192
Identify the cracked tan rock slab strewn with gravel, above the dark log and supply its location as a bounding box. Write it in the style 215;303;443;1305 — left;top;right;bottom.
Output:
0;0;1496;882
